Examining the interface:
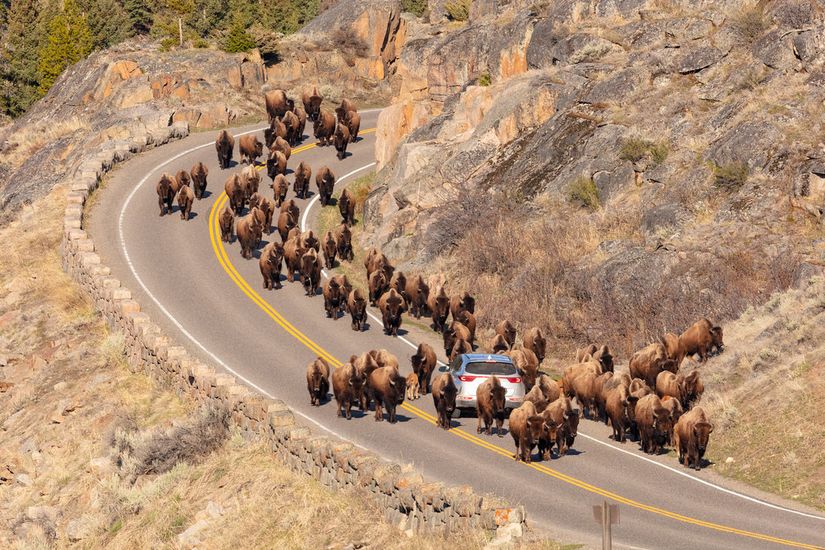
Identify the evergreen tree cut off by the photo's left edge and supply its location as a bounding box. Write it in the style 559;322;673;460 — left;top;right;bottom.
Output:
0;0;40;116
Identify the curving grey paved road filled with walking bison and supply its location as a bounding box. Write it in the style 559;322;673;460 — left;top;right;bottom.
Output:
88;112;825;549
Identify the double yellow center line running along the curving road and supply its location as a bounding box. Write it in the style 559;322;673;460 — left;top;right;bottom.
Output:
204;128;822;550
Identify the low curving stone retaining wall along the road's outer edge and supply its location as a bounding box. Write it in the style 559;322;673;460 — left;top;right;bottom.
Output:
62;122;525;536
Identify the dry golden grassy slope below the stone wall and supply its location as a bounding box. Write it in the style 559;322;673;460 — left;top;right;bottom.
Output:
0;185;568;548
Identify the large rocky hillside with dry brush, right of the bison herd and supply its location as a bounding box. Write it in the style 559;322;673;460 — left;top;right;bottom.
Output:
365;0;825;357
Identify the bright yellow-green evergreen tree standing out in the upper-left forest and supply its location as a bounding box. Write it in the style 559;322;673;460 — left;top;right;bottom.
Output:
37;0;93;94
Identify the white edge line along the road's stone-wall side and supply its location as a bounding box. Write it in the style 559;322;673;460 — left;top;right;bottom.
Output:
118;123;381;451
